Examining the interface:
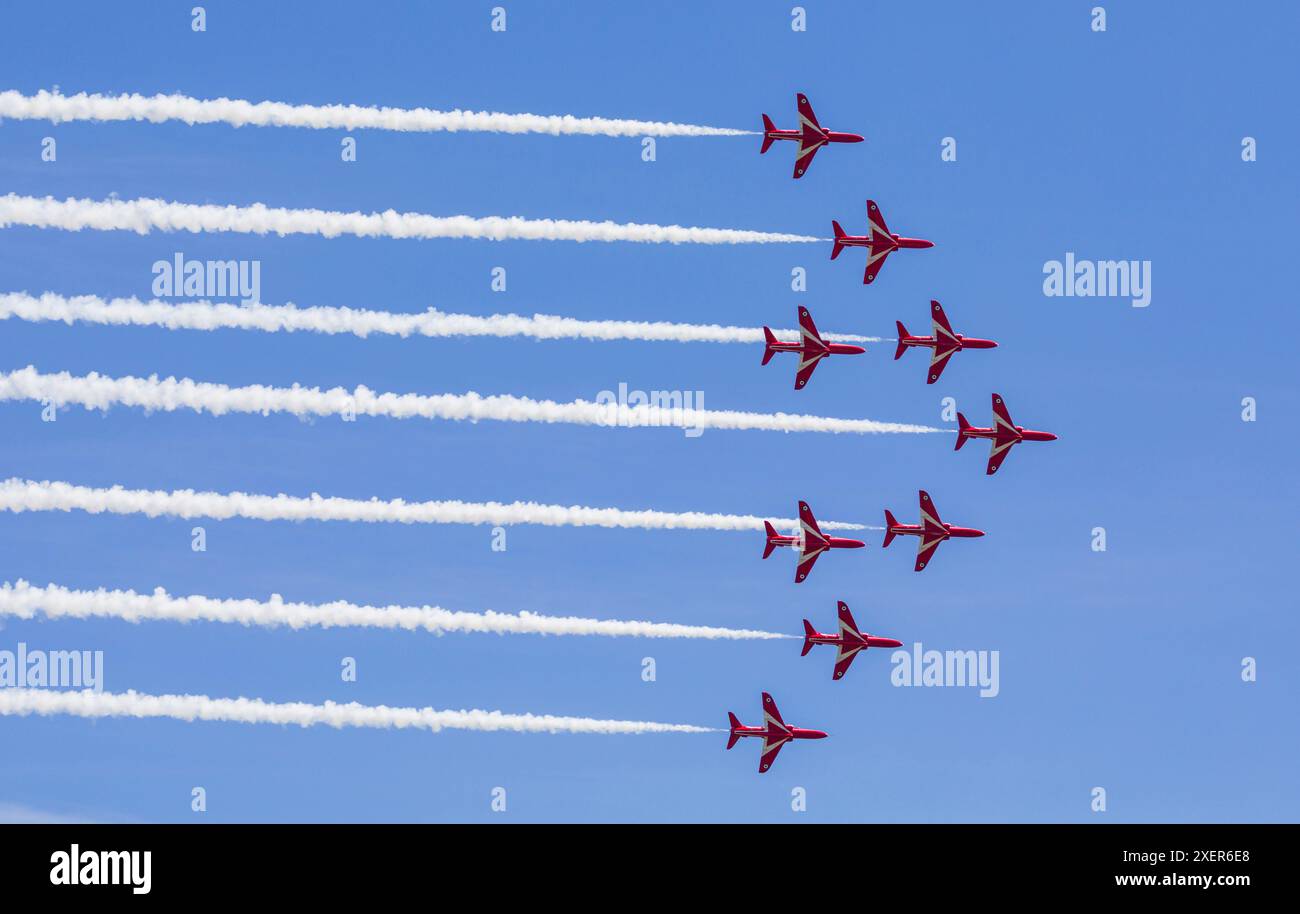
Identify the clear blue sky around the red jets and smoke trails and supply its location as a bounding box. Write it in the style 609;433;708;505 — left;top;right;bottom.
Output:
0;1;1300;822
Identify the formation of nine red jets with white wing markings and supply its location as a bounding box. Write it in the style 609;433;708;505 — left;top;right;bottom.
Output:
727;92;1056;772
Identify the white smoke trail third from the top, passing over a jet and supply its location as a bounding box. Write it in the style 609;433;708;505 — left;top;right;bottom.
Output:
0;293;880;343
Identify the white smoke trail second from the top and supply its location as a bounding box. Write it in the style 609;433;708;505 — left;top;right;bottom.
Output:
0;194;826;244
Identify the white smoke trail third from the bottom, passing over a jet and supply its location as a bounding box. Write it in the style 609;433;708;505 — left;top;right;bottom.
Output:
0;478;878;530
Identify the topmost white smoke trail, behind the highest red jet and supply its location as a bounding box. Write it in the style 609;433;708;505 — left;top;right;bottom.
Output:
0;90;755;137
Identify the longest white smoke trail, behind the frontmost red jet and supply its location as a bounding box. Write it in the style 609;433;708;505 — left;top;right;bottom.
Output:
0;365;945;434
